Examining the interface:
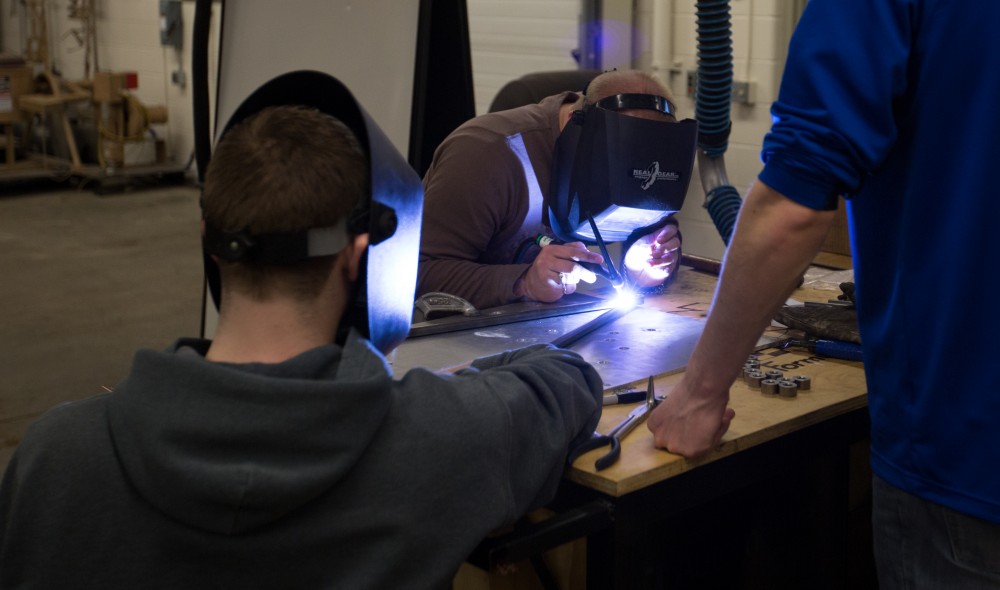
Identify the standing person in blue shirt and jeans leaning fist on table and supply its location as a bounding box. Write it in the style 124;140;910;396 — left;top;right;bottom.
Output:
649;0;1000;590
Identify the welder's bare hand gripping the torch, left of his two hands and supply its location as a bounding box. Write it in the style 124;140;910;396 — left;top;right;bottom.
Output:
514;242;604;303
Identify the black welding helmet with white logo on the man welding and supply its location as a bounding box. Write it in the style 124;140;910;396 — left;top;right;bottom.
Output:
549;94;698;244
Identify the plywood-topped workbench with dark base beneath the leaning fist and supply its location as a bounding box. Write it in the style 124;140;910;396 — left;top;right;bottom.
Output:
460;268;874;590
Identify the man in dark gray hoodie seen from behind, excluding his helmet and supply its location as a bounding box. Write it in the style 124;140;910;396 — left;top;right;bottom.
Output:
0;80;602;590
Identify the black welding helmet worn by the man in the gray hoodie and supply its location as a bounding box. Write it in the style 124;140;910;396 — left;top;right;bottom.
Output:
203;71;424;353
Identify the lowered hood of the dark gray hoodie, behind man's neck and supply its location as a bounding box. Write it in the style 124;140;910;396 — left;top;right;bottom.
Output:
110;337;392;535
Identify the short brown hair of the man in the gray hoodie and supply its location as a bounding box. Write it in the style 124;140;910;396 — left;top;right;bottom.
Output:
202;106;368;299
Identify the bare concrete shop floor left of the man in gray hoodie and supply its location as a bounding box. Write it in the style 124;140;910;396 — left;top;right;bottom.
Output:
0;185;202;469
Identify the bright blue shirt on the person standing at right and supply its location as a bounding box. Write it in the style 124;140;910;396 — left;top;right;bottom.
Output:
760;0;1000;522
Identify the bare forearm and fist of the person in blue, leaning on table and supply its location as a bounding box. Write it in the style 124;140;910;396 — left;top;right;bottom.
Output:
647;182;833;457
